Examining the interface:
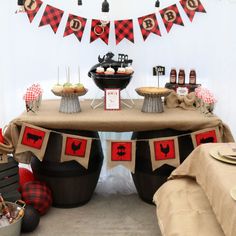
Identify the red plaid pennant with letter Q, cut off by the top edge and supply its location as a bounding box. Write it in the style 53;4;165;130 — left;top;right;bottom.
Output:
180;0;206;21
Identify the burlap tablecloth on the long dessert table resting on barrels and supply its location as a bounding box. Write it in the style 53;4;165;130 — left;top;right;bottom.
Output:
0;99;233;161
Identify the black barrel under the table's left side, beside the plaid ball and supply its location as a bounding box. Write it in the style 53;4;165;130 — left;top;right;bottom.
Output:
31;130;103;208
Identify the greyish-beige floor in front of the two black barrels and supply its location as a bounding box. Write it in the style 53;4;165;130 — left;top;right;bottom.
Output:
22;193;161;236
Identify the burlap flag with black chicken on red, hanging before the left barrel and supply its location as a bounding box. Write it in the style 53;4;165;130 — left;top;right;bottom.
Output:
61;134;92;169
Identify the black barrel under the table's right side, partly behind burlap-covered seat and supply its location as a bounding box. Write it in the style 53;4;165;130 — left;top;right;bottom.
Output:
132;129;193;203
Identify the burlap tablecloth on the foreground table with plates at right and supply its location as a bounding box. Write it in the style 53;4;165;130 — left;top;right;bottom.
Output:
164;144;236;236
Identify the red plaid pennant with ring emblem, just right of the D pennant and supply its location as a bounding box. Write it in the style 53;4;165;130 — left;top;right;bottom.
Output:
90;19;110;44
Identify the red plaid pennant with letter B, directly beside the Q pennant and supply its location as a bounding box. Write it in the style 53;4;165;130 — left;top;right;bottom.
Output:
160;4;184;32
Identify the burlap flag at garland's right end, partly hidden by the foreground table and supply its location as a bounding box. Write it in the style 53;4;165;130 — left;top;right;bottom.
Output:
191;127;222;148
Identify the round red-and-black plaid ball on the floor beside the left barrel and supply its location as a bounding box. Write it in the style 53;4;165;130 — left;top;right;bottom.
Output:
21;181;52;215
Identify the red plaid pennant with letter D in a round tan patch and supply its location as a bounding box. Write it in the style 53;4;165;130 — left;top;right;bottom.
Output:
63;14;87;41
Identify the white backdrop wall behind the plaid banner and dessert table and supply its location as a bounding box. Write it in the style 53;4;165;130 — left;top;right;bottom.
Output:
0;0;236;138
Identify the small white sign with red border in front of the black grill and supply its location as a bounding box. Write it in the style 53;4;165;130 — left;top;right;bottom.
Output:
104;89;120;110
